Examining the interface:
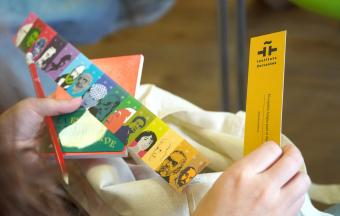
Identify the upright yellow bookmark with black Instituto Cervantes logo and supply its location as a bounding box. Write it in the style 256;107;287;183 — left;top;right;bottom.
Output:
244;31;287;155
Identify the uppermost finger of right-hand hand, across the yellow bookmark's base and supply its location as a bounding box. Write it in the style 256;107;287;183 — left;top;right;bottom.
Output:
241;141;282;174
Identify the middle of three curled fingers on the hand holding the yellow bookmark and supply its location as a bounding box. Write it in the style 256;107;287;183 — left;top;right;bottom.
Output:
265;145;303;187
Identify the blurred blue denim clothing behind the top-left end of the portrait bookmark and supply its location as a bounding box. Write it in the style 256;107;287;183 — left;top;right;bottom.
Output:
0;0;175;110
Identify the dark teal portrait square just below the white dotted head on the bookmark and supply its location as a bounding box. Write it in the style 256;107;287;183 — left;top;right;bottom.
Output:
89;92;121;121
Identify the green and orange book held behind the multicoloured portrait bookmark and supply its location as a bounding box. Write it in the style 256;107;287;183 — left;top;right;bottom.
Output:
49;55;144;158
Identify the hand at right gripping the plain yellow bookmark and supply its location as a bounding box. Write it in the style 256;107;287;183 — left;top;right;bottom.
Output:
194;142;311;216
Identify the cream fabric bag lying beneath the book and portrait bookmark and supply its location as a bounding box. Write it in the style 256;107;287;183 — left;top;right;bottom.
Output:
67;85;340;216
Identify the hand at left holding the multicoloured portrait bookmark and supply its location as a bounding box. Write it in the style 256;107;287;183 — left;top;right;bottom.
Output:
0;98;81;150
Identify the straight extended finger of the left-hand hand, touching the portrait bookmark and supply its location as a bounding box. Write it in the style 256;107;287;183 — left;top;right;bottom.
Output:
27;98;82;117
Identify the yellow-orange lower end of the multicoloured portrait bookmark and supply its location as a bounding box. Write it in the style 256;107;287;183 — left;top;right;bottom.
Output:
141;129;209;192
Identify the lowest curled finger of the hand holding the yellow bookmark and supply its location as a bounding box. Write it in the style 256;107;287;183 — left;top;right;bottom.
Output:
281;172;311;205
